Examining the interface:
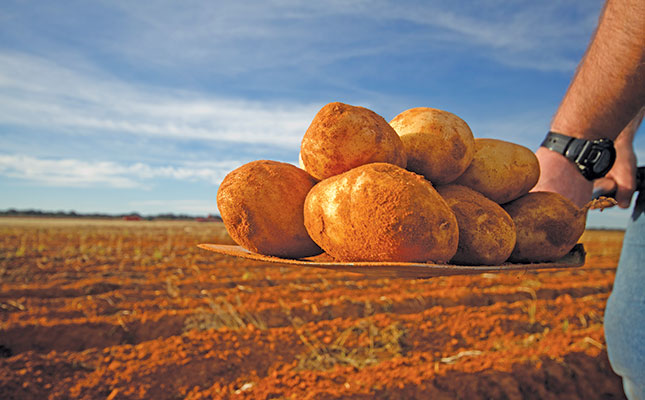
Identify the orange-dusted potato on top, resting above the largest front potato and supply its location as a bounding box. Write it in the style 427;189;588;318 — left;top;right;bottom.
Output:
300;102;407;180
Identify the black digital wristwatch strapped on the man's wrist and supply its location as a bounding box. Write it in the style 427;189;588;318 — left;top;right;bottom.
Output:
541;132;616;181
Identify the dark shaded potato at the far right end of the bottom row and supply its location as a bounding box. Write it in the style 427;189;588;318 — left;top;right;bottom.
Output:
503;192;586;262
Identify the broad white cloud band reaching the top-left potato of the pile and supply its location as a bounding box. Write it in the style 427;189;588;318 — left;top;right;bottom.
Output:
0;52;320;147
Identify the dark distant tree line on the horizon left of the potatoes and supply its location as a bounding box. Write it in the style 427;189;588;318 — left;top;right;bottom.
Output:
0;208;222;221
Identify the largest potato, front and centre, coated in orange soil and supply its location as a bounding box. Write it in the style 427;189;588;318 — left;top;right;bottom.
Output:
304;163;459;263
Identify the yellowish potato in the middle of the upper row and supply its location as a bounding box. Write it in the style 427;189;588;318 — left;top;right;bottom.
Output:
390;107;475;185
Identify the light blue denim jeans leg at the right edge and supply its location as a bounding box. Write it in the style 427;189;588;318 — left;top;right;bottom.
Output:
604;192;645;400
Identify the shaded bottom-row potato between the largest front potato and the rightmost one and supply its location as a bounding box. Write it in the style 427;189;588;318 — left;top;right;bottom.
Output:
437;184;515;265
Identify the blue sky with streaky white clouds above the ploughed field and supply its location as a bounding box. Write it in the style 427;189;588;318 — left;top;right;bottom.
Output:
0;0;645;227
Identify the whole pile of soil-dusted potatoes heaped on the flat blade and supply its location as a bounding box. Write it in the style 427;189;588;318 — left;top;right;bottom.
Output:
217;102;586;265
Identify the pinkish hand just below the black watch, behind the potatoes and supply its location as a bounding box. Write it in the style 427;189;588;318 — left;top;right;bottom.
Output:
531;147;593;207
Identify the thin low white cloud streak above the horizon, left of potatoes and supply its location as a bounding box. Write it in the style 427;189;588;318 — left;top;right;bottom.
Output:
0;155;242;189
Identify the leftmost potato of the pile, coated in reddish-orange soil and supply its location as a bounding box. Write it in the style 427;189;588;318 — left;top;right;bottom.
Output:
217;160;322;258
